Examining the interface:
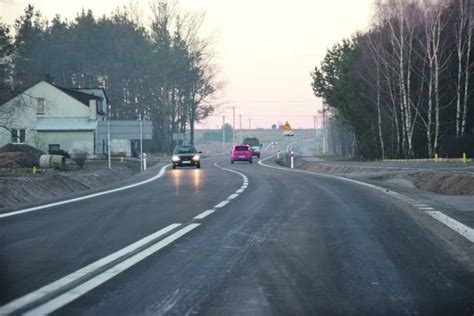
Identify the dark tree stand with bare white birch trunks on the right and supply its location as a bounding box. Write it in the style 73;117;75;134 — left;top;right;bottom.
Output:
311;0;474;159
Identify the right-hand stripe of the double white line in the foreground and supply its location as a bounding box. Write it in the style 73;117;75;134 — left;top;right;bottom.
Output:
24;223;201;315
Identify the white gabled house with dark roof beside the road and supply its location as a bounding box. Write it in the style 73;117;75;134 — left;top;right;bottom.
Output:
0;80;107;155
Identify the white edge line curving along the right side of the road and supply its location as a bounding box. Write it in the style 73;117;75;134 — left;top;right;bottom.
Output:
258;155;474;242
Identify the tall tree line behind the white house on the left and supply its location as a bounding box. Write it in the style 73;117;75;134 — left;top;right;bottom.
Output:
0;0;220;151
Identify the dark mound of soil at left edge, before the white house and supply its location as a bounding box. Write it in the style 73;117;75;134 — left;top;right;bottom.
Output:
0;144;44;168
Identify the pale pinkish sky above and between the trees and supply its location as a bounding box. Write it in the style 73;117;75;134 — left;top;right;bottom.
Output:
0;0;373;129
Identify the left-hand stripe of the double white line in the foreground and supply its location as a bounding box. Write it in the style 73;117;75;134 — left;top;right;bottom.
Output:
0;224;181;315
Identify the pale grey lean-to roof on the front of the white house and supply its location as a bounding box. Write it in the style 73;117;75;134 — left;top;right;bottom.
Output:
33;117;97;131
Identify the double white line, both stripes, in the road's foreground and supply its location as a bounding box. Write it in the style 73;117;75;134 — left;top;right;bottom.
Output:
0;223;201;315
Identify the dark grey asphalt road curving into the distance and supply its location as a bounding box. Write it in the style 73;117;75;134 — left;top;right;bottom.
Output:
0;154;474;315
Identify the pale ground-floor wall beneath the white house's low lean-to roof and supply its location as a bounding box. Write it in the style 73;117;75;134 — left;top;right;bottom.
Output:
38;131;94;154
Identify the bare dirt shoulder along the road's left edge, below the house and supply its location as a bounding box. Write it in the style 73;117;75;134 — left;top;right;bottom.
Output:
0;160;159;211
